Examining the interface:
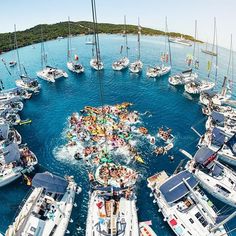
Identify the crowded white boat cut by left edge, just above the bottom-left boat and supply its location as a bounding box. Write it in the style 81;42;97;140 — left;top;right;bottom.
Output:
0;142;38;187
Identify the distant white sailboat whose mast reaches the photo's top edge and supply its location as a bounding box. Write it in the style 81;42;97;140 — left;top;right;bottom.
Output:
90;0;104;70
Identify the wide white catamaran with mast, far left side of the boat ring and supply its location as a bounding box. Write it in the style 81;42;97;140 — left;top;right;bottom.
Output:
36;28;68;83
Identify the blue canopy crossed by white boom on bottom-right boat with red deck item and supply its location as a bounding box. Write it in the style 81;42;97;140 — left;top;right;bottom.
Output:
160;170;198;203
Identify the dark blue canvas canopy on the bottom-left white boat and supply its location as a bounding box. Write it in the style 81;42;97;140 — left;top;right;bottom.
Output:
32;172;68;194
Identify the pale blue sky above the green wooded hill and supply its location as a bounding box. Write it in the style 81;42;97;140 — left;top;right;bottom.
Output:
0;0;236;48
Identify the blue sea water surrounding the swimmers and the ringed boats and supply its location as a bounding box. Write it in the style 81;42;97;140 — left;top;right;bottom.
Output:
0;35;236;235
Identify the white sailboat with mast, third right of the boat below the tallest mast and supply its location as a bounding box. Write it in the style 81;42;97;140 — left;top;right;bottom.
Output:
146;17;171;78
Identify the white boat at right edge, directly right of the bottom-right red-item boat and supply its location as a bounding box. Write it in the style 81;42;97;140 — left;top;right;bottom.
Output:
181;147;236;207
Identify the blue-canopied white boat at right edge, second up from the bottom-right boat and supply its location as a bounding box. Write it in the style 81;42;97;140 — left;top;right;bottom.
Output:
198;127;236;166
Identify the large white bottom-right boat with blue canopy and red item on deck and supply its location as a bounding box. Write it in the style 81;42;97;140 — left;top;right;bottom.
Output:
147;170;227;236
